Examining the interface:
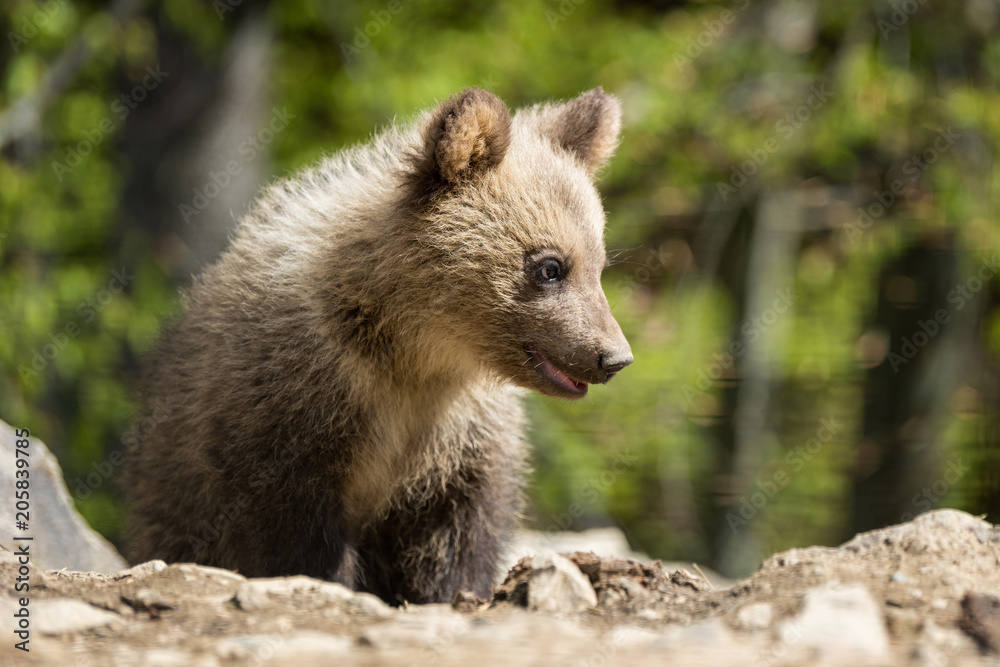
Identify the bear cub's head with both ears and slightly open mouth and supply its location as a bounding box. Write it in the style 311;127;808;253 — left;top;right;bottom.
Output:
404;88;632;398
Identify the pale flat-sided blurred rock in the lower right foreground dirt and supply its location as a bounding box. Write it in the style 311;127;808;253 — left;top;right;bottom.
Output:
781;584;889;660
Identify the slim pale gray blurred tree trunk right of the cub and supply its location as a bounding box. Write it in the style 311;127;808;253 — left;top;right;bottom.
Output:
706;191;802;576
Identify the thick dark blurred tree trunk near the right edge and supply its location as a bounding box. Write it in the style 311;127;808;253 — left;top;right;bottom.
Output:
844;234;974;537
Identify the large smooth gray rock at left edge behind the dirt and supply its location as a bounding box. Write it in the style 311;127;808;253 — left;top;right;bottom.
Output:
0;420;127;573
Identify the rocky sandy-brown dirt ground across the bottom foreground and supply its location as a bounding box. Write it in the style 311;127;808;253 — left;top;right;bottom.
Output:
0;510;1000;667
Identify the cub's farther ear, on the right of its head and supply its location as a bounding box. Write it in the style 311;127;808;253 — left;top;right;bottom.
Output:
540;87;622;174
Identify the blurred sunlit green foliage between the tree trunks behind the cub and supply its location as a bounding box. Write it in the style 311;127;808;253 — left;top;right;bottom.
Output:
0;0;1000;576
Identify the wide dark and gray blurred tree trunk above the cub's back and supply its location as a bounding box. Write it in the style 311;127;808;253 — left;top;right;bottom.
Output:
120;2;273;285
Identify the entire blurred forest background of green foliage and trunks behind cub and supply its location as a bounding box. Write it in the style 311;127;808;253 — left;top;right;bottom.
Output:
0;0;1000;575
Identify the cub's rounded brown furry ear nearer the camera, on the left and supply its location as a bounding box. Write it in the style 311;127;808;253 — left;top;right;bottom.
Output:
418;88;511;189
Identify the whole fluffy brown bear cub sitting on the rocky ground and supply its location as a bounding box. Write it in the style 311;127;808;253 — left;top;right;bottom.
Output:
123;88;632;604
